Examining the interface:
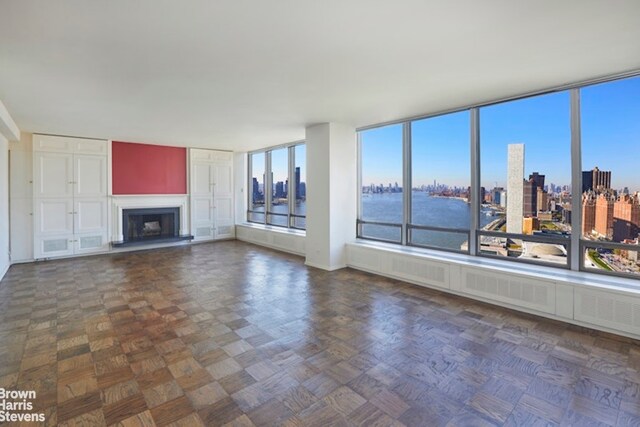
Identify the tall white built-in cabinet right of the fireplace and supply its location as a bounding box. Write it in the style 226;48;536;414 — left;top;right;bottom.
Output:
189;149;235;241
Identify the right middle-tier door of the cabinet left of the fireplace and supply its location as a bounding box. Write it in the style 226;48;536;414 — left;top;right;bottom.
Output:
73;154;107;197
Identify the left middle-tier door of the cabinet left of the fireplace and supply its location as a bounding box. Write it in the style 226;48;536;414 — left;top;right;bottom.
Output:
33;152;73;197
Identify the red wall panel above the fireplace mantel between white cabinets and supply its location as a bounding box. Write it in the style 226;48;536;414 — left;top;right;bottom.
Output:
112;141;187;194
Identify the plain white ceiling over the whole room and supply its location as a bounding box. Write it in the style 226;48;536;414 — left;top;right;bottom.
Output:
0;0;640;150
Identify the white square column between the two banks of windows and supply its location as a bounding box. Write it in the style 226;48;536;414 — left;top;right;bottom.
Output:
305;123;357;271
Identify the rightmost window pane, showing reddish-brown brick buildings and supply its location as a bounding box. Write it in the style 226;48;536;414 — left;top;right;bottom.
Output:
575;77;640;275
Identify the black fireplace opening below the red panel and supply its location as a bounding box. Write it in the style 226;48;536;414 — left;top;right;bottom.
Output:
122;208;180;244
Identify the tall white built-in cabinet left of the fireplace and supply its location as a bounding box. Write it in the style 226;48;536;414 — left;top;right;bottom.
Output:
33;135;109;259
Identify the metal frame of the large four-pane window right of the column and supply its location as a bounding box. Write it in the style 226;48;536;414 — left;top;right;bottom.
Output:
356;70;640;280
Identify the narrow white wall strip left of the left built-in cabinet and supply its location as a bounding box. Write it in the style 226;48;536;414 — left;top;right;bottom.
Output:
9;132;33;263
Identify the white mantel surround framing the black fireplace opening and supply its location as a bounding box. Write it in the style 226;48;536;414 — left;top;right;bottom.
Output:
111;194;190;242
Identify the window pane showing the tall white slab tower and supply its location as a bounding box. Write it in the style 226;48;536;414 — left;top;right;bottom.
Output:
478;91;571;267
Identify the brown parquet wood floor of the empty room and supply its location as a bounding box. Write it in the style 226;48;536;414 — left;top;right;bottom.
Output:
0;241;640;426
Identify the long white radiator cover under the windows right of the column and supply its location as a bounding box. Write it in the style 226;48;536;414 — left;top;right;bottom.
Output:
347;243;640;339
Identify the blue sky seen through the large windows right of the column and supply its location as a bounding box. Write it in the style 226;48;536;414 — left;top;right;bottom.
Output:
362;77;640;191
